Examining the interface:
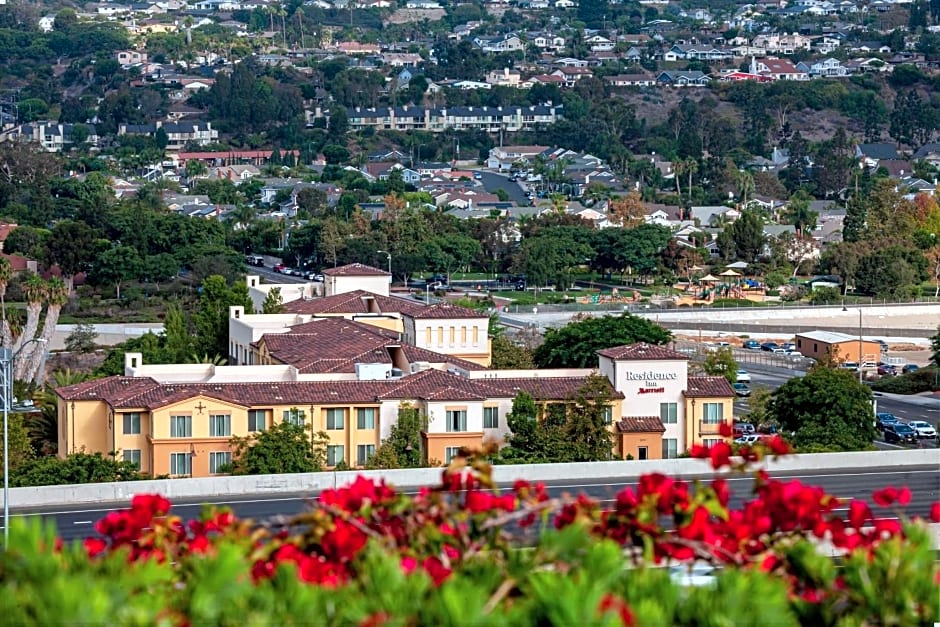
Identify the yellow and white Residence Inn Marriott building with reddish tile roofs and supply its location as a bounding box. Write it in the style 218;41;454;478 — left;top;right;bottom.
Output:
56;340;734;477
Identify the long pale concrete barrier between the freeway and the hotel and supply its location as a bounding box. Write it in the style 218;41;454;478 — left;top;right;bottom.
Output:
3;449;938;511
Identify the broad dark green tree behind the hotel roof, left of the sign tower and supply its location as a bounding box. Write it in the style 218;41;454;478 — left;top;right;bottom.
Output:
533;313;672;368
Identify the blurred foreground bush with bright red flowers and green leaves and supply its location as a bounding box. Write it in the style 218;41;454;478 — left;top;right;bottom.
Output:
0;439;940;626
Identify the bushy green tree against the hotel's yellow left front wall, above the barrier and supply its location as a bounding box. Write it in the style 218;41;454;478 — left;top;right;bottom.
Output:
230;422;329;475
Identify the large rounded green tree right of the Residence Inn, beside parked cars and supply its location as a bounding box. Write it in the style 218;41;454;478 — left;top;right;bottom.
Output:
768;365;875;452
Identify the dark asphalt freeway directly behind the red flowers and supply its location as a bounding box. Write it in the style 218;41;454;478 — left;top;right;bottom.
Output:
11;460;940;540
